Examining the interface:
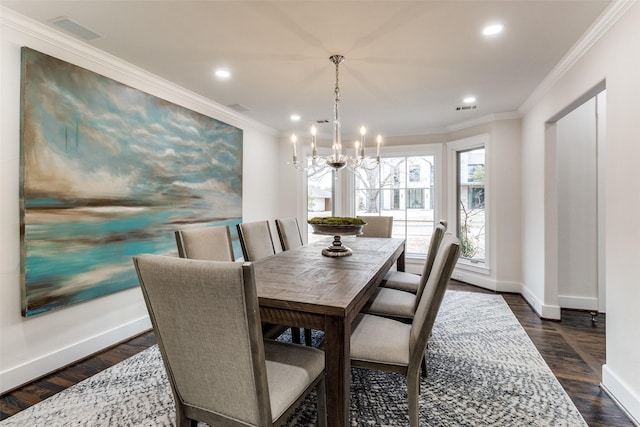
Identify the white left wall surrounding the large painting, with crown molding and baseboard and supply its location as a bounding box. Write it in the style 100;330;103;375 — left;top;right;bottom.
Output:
0;9;279;392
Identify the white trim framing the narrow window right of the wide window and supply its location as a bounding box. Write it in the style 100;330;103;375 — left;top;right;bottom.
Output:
446;133;492;274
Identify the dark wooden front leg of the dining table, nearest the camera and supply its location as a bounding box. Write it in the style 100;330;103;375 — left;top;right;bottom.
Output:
324;316;351;427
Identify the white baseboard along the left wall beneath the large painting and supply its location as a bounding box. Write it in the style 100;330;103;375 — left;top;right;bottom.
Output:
0;316;151;393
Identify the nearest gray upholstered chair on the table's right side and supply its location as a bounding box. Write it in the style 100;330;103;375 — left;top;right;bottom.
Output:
351;234;460;427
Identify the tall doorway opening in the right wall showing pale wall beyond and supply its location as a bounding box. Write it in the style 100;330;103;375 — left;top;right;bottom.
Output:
554;90;606;312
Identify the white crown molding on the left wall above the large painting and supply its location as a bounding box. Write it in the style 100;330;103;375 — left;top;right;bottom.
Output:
0;6;277;136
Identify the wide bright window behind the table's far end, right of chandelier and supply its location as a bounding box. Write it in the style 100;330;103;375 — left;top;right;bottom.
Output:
354;155;439;256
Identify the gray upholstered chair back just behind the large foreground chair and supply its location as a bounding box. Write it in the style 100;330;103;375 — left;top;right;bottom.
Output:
175;225;235;261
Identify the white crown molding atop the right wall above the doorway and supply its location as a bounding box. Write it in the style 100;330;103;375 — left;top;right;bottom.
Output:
518;0;637;115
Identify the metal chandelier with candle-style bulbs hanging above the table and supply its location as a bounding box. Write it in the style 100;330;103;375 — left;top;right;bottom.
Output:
291;55;382;172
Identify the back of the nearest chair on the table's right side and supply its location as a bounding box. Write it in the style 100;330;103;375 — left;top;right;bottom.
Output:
407;234;460;375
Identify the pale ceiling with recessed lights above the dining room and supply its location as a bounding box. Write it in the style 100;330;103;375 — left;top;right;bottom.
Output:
2;0;611;138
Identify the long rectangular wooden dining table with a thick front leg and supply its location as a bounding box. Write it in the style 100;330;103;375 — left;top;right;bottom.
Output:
254;237;405;427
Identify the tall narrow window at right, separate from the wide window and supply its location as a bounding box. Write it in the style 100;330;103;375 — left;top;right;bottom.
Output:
449;137;486;264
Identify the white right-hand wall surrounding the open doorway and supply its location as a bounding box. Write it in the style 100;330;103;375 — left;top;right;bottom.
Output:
522;2;640;420
